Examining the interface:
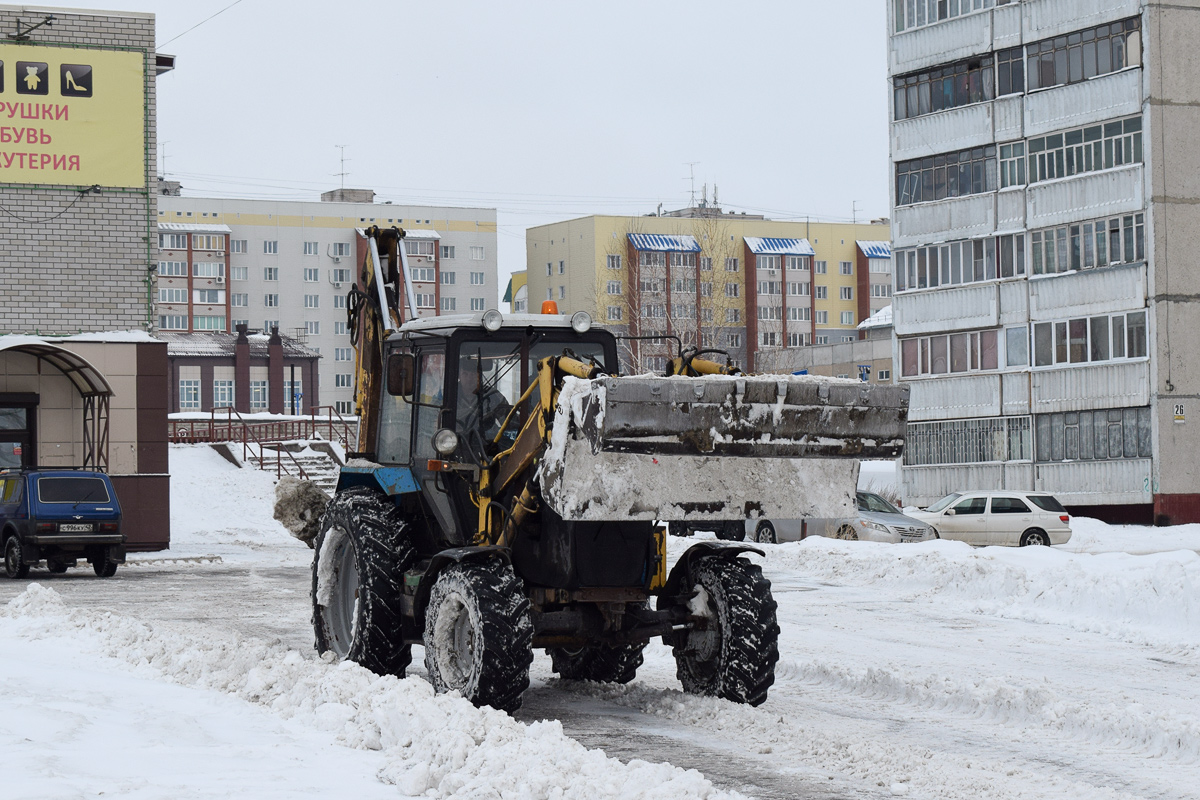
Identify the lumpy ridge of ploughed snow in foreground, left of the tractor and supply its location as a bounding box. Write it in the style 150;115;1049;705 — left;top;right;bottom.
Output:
0;583;740;800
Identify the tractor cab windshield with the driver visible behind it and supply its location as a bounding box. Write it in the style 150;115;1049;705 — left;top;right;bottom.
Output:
455;341;521;452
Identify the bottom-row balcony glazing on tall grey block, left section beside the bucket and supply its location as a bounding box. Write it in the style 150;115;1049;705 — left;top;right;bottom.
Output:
902;417;1033;467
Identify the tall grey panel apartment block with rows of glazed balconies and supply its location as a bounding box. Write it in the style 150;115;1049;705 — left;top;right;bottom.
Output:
888;0;1200;523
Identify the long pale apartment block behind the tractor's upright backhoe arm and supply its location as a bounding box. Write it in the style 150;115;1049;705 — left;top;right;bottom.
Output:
157;190;499;414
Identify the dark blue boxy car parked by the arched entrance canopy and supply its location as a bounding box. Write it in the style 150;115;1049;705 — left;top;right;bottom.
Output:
0;469;125;578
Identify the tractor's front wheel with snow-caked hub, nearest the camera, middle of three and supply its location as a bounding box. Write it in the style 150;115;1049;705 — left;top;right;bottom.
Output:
425;559;533;711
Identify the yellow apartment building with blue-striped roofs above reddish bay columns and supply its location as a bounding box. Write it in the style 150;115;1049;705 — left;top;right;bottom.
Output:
526;206;892;371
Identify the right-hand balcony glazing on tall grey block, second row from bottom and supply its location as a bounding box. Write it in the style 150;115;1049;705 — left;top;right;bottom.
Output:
1033;311;1146;367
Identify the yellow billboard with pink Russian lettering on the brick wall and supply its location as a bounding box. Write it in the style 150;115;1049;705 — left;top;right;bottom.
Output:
0;42;146;188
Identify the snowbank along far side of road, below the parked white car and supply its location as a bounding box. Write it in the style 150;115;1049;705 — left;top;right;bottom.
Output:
768;527;1200;651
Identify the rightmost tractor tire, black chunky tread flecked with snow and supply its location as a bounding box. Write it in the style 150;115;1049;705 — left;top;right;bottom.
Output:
672;555;779;705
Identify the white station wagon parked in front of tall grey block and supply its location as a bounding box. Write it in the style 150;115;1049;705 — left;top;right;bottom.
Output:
905;492;1070;547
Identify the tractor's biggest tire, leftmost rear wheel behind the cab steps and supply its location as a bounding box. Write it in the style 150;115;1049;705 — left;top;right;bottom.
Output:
312;487;416;676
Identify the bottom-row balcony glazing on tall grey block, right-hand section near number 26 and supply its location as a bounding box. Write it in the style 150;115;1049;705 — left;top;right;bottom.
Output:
1033;407;1152;462
